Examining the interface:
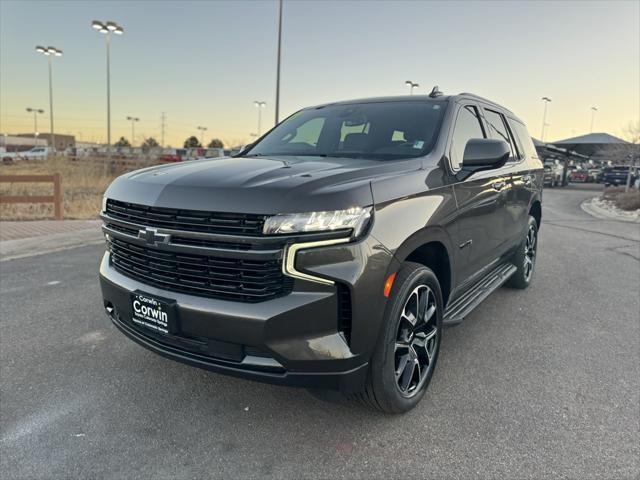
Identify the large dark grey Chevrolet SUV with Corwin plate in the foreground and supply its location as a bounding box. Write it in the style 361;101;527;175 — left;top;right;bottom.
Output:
100;93;543;413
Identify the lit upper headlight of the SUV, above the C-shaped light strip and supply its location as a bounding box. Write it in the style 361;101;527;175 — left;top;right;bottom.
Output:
262;207;371;237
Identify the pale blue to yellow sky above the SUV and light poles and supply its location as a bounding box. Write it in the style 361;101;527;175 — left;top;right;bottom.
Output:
0;0;640;145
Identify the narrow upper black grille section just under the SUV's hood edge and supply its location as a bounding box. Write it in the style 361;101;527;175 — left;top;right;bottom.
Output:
106;199;265;236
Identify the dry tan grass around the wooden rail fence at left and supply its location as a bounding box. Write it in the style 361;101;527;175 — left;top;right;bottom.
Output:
0;157;159;220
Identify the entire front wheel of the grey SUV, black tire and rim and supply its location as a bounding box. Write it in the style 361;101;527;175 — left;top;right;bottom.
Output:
355;262;443;414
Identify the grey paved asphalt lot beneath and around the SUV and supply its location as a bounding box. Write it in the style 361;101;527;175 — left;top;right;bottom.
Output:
0;186;640;479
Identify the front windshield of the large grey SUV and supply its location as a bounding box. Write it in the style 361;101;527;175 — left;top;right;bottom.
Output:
245;100;446;160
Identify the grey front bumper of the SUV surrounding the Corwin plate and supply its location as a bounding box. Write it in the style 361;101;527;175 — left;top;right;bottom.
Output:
100;232;395;393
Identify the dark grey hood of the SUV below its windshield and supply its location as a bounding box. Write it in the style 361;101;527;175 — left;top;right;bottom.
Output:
106;156;421;214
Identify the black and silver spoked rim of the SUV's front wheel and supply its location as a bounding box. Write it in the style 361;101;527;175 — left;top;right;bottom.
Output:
394;285;438;397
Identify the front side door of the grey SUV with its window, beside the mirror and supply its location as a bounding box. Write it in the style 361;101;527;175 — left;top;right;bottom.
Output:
448;103;506;290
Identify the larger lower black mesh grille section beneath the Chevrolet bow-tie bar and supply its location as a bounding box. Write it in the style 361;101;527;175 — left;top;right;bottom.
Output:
109;238;293;302
